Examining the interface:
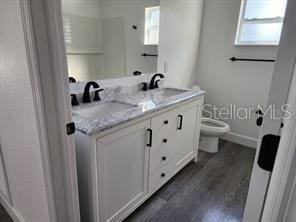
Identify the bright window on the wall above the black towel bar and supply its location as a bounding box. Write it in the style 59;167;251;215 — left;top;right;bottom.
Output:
235;0;287;45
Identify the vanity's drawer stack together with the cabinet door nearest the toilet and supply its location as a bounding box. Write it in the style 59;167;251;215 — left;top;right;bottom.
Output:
149;99;202;192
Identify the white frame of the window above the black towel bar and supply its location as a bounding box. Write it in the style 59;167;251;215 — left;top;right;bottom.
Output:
234;0;284;46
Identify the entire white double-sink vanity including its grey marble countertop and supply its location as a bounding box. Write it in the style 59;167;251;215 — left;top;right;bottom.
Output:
73;77;204;222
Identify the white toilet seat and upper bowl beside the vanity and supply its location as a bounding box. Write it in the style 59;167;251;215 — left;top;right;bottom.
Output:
200;117;230;136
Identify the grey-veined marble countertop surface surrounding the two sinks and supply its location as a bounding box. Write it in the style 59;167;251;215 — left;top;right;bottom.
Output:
72;87;205;135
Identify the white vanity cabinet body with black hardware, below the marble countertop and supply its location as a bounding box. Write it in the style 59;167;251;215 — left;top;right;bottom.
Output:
75;96;203;222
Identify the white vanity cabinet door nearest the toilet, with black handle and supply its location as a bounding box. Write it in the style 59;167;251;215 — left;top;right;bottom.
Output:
173;100;202;171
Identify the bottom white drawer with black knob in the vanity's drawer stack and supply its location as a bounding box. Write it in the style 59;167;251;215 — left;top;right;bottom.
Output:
148;164;172;192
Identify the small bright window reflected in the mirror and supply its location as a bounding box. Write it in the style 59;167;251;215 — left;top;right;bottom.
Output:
144;6;159;45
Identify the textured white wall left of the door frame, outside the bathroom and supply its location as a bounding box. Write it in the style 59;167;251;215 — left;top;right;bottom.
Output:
0;0;50;222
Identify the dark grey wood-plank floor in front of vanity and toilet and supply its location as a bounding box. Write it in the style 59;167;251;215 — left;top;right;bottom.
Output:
125;141;255;222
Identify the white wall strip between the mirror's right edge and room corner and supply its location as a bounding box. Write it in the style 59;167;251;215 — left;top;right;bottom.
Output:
158;0;203;87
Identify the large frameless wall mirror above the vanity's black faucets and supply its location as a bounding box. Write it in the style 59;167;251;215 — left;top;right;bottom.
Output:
62;0;160;81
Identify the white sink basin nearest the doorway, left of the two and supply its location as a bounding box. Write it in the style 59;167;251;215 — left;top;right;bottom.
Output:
74;101;136;120
